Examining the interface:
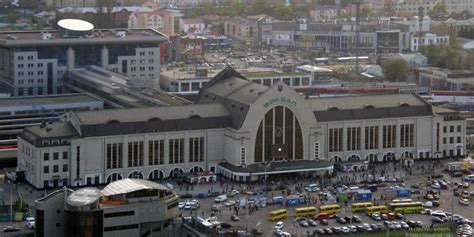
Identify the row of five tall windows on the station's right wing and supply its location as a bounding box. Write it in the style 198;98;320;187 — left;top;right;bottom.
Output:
328;124;415;152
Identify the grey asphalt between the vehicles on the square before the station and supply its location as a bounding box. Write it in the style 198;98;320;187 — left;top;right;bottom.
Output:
178;158;474;236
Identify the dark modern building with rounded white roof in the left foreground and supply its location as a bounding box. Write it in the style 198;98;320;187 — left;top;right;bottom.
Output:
35;179;179;237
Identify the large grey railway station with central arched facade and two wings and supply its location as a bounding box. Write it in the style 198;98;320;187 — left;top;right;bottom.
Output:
18;68;466;188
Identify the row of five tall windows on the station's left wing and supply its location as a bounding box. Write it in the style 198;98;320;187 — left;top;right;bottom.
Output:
105;137;205;169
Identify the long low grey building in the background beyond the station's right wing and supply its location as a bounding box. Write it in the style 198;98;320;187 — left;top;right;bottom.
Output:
261;22;409;53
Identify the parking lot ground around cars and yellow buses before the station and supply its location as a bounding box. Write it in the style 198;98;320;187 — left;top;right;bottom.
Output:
179;158;474;236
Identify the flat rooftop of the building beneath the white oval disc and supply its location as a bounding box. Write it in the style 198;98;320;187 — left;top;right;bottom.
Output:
0;29;166;46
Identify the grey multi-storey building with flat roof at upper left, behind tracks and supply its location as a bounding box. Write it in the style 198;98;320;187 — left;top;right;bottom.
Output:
0;23;166;96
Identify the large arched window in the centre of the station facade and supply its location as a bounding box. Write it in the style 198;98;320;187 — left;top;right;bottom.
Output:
255;106;303;163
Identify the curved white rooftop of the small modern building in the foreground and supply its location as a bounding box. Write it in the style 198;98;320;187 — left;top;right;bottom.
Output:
100;179;169;197
